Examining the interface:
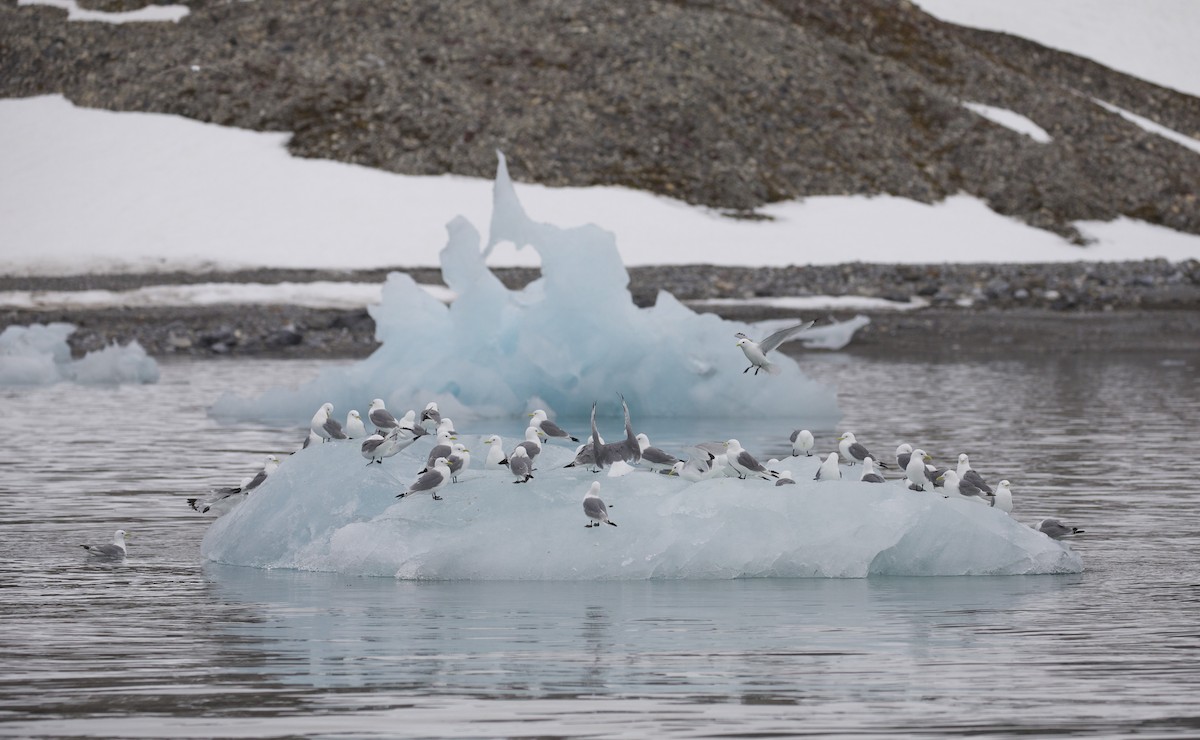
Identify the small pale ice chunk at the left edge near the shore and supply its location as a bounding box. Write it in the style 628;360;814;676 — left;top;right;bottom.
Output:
0;323;158;386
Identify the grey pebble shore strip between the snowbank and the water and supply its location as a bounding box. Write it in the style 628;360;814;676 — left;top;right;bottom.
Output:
0;260;1200;359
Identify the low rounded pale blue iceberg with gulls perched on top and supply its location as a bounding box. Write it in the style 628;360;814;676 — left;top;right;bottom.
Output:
202;439;1082;580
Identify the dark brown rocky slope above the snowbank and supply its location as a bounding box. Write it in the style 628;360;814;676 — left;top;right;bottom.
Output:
0;0;1200;240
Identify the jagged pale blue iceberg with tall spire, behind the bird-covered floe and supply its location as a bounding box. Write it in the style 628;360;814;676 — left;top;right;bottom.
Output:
210;155;839;428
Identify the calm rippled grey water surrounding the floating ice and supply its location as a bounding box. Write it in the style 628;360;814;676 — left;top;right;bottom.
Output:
0;347;1200;738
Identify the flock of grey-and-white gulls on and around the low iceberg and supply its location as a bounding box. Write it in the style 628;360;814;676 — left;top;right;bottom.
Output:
82;321;1084;559
